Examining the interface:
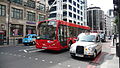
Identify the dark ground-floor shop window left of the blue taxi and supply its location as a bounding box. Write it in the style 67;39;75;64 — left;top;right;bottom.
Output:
10;24;23;36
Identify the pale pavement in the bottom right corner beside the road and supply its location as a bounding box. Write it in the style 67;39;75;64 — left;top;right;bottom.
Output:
100;40;119;68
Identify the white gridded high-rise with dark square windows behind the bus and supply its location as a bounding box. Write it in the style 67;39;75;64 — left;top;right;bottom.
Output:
48;0;87;25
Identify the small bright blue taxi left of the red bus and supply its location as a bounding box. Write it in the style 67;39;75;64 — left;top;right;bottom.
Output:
22;34;37;45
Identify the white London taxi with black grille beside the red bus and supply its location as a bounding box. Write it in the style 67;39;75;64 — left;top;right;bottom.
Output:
70;33;102;58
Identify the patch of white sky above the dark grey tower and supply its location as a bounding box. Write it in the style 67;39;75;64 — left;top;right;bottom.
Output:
87;0;113;13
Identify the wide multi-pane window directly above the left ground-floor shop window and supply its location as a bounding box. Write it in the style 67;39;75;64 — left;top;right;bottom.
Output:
11;8;23;19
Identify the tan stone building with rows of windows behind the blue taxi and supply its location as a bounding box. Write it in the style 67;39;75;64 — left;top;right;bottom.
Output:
0;0;45;43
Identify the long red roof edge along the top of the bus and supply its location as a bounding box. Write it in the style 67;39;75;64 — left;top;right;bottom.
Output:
38;19;90;29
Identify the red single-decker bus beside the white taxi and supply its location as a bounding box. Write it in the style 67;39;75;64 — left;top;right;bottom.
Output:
36;20;90;51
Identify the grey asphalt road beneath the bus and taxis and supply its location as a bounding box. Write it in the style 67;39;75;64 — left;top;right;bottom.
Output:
0;41;114;68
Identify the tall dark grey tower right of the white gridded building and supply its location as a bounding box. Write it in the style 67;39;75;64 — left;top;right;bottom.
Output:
87;7;105;31
